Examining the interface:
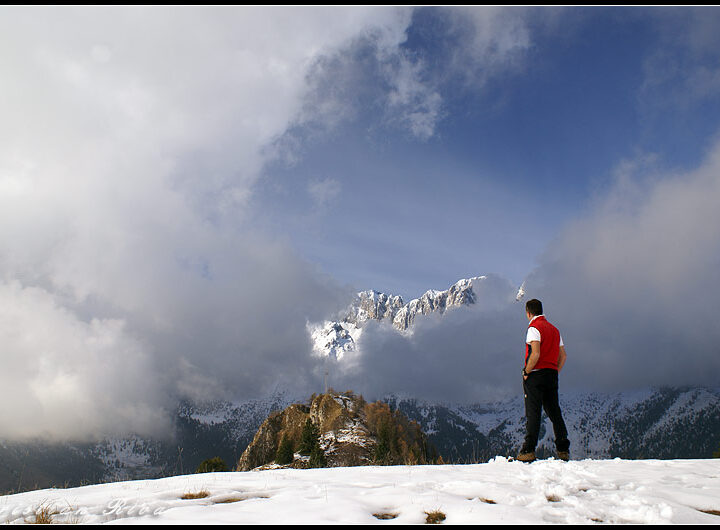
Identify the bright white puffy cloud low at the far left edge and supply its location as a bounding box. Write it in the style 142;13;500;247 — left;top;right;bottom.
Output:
0;282;168;438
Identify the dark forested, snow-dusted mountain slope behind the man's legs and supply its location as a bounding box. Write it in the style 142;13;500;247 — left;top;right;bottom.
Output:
387;388;720;462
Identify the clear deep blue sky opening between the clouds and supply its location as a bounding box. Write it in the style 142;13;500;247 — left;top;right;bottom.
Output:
246;8;720;297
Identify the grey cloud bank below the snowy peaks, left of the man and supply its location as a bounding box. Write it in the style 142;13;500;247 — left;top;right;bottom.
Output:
328;276;524;402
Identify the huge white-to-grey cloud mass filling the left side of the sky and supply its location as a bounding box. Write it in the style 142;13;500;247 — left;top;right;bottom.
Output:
0;7;416;438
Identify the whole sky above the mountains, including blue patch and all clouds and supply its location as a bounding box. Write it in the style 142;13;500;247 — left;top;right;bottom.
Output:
0;7;720;439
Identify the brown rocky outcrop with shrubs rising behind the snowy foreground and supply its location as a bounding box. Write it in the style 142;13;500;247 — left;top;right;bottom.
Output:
237;392;434;471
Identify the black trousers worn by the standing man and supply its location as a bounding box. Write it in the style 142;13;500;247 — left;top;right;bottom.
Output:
521;369;570;453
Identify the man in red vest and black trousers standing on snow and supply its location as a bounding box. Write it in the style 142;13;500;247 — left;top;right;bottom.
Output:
517;299;570;462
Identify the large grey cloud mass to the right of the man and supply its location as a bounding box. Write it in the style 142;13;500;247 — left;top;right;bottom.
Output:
528;145;720;388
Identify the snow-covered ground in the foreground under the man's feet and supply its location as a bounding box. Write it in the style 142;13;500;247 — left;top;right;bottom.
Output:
0;457;720;524
